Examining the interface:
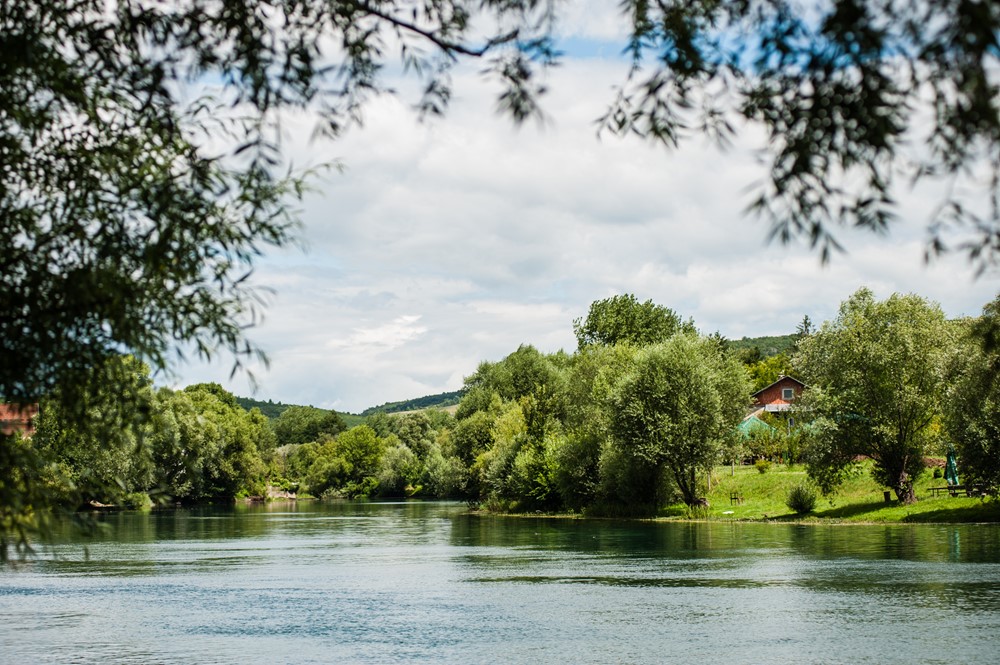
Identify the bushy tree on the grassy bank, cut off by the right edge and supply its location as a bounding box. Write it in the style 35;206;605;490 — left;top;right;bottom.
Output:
944;296;1000;494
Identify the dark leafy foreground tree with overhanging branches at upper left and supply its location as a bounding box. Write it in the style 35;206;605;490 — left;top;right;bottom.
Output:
0;0;532;554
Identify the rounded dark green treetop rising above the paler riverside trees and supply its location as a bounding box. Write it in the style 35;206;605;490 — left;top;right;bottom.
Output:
573;293;694;349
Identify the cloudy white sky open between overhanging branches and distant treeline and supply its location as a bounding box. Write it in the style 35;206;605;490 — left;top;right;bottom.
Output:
172;18;1000;413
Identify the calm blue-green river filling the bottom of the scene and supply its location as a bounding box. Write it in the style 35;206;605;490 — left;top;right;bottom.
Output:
0;502;1000;665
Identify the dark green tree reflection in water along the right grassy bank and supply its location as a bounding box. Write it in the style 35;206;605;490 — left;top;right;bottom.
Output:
449;515;1000;621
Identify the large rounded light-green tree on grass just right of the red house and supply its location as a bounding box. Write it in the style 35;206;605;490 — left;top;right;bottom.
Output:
796;288;952;503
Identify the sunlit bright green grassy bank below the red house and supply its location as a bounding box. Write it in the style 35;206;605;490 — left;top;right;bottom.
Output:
680;464;1000;523
